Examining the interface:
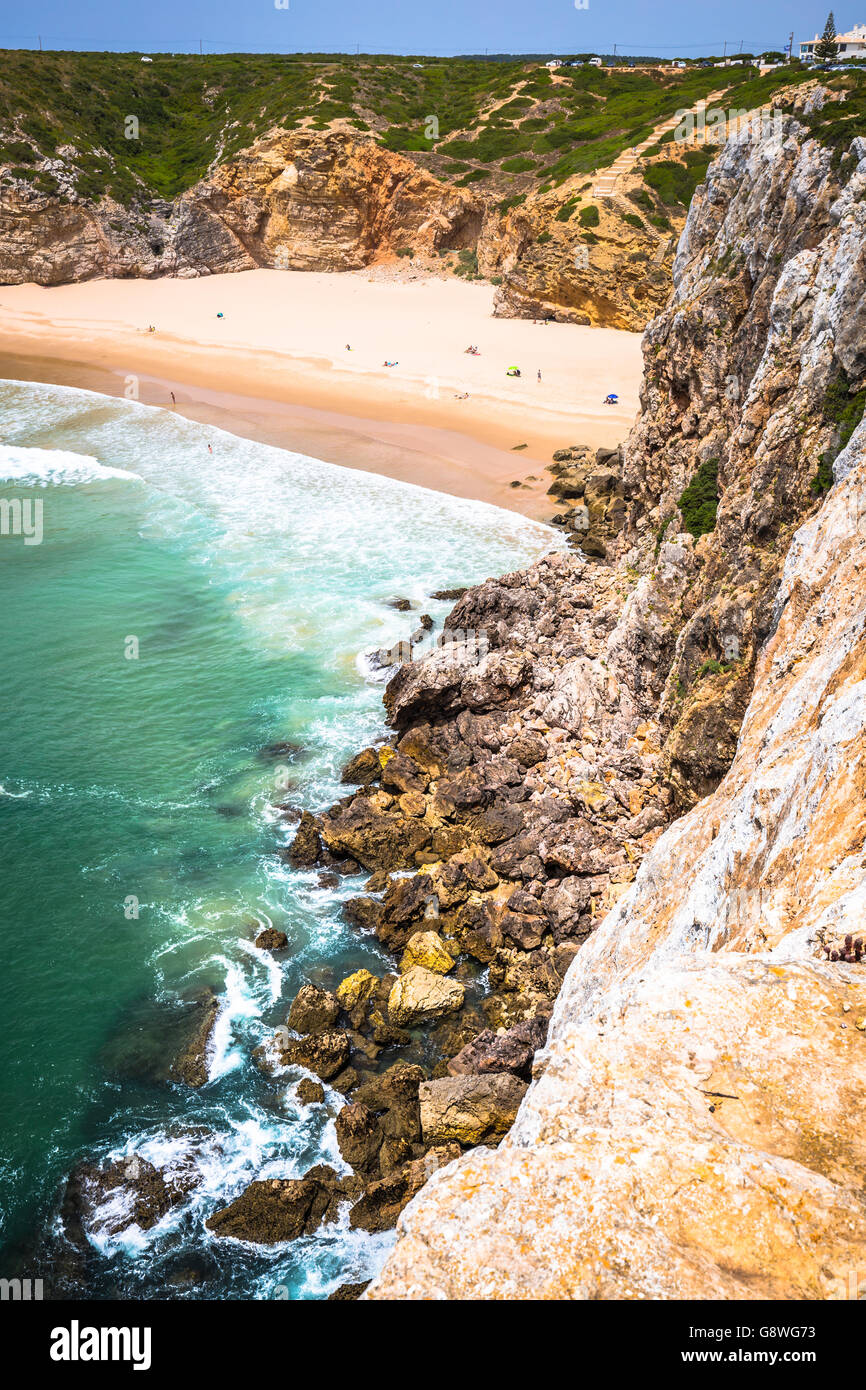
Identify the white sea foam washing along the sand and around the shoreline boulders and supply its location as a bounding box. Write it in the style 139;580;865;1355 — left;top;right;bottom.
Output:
0;382;563;1298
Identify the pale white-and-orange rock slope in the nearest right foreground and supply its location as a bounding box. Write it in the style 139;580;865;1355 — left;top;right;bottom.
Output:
370;411;866;1298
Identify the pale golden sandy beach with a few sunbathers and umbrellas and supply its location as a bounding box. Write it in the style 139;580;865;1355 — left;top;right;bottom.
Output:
0;270;641;517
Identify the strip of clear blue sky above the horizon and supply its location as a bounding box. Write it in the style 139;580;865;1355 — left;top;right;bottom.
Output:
0;0;839;57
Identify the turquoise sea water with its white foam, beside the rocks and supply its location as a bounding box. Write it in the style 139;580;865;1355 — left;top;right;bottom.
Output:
0;382;555;1298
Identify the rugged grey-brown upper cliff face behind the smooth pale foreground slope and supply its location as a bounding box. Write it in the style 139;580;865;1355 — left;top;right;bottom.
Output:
624;121;866;805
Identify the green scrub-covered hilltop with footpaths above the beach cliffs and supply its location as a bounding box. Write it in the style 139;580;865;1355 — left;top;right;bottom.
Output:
0;50;828;206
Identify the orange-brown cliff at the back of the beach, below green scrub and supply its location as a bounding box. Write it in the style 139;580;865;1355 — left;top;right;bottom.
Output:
0;131;482;285
